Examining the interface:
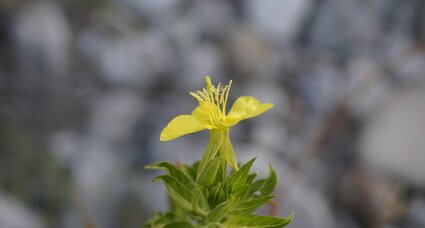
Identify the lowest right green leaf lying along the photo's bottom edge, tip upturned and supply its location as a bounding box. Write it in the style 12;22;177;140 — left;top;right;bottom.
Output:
224;214;293;228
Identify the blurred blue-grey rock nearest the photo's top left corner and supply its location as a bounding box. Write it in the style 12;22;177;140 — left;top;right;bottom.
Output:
12;1;71;76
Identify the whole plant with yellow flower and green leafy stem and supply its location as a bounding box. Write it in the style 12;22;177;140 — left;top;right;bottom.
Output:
145;76;293;228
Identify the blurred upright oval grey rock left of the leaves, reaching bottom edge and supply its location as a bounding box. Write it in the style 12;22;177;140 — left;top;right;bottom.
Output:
72;138;127;227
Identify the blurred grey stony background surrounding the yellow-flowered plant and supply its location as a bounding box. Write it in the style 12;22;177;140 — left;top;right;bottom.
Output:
0;0;425;228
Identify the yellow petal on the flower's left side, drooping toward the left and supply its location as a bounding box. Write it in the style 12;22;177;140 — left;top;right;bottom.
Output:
160;115;205;141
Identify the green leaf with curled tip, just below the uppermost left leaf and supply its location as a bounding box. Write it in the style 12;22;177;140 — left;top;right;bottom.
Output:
155;175;193;211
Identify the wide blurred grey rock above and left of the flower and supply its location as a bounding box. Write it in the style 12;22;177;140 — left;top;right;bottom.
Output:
78;29;178;87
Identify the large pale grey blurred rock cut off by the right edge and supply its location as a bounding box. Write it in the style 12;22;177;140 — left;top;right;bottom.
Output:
360;87;425;187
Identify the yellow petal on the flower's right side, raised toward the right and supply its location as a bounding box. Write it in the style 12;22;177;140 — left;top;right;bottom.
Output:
226;96;273;126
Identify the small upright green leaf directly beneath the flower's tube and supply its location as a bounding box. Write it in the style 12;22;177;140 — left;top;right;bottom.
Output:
197;158;224;187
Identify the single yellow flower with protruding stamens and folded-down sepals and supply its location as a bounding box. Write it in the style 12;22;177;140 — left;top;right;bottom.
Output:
160;76;273;173
